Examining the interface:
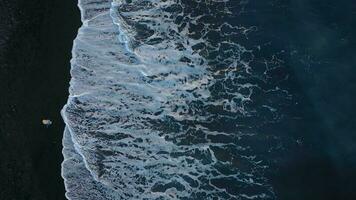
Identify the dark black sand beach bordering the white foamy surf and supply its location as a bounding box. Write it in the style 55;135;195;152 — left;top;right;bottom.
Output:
0;0;80;200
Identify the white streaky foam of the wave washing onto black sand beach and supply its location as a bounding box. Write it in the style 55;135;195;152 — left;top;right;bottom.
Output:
62;0;290;200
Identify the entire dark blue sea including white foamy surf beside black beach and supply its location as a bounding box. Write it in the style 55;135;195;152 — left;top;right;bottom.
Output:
62;0;356;200
